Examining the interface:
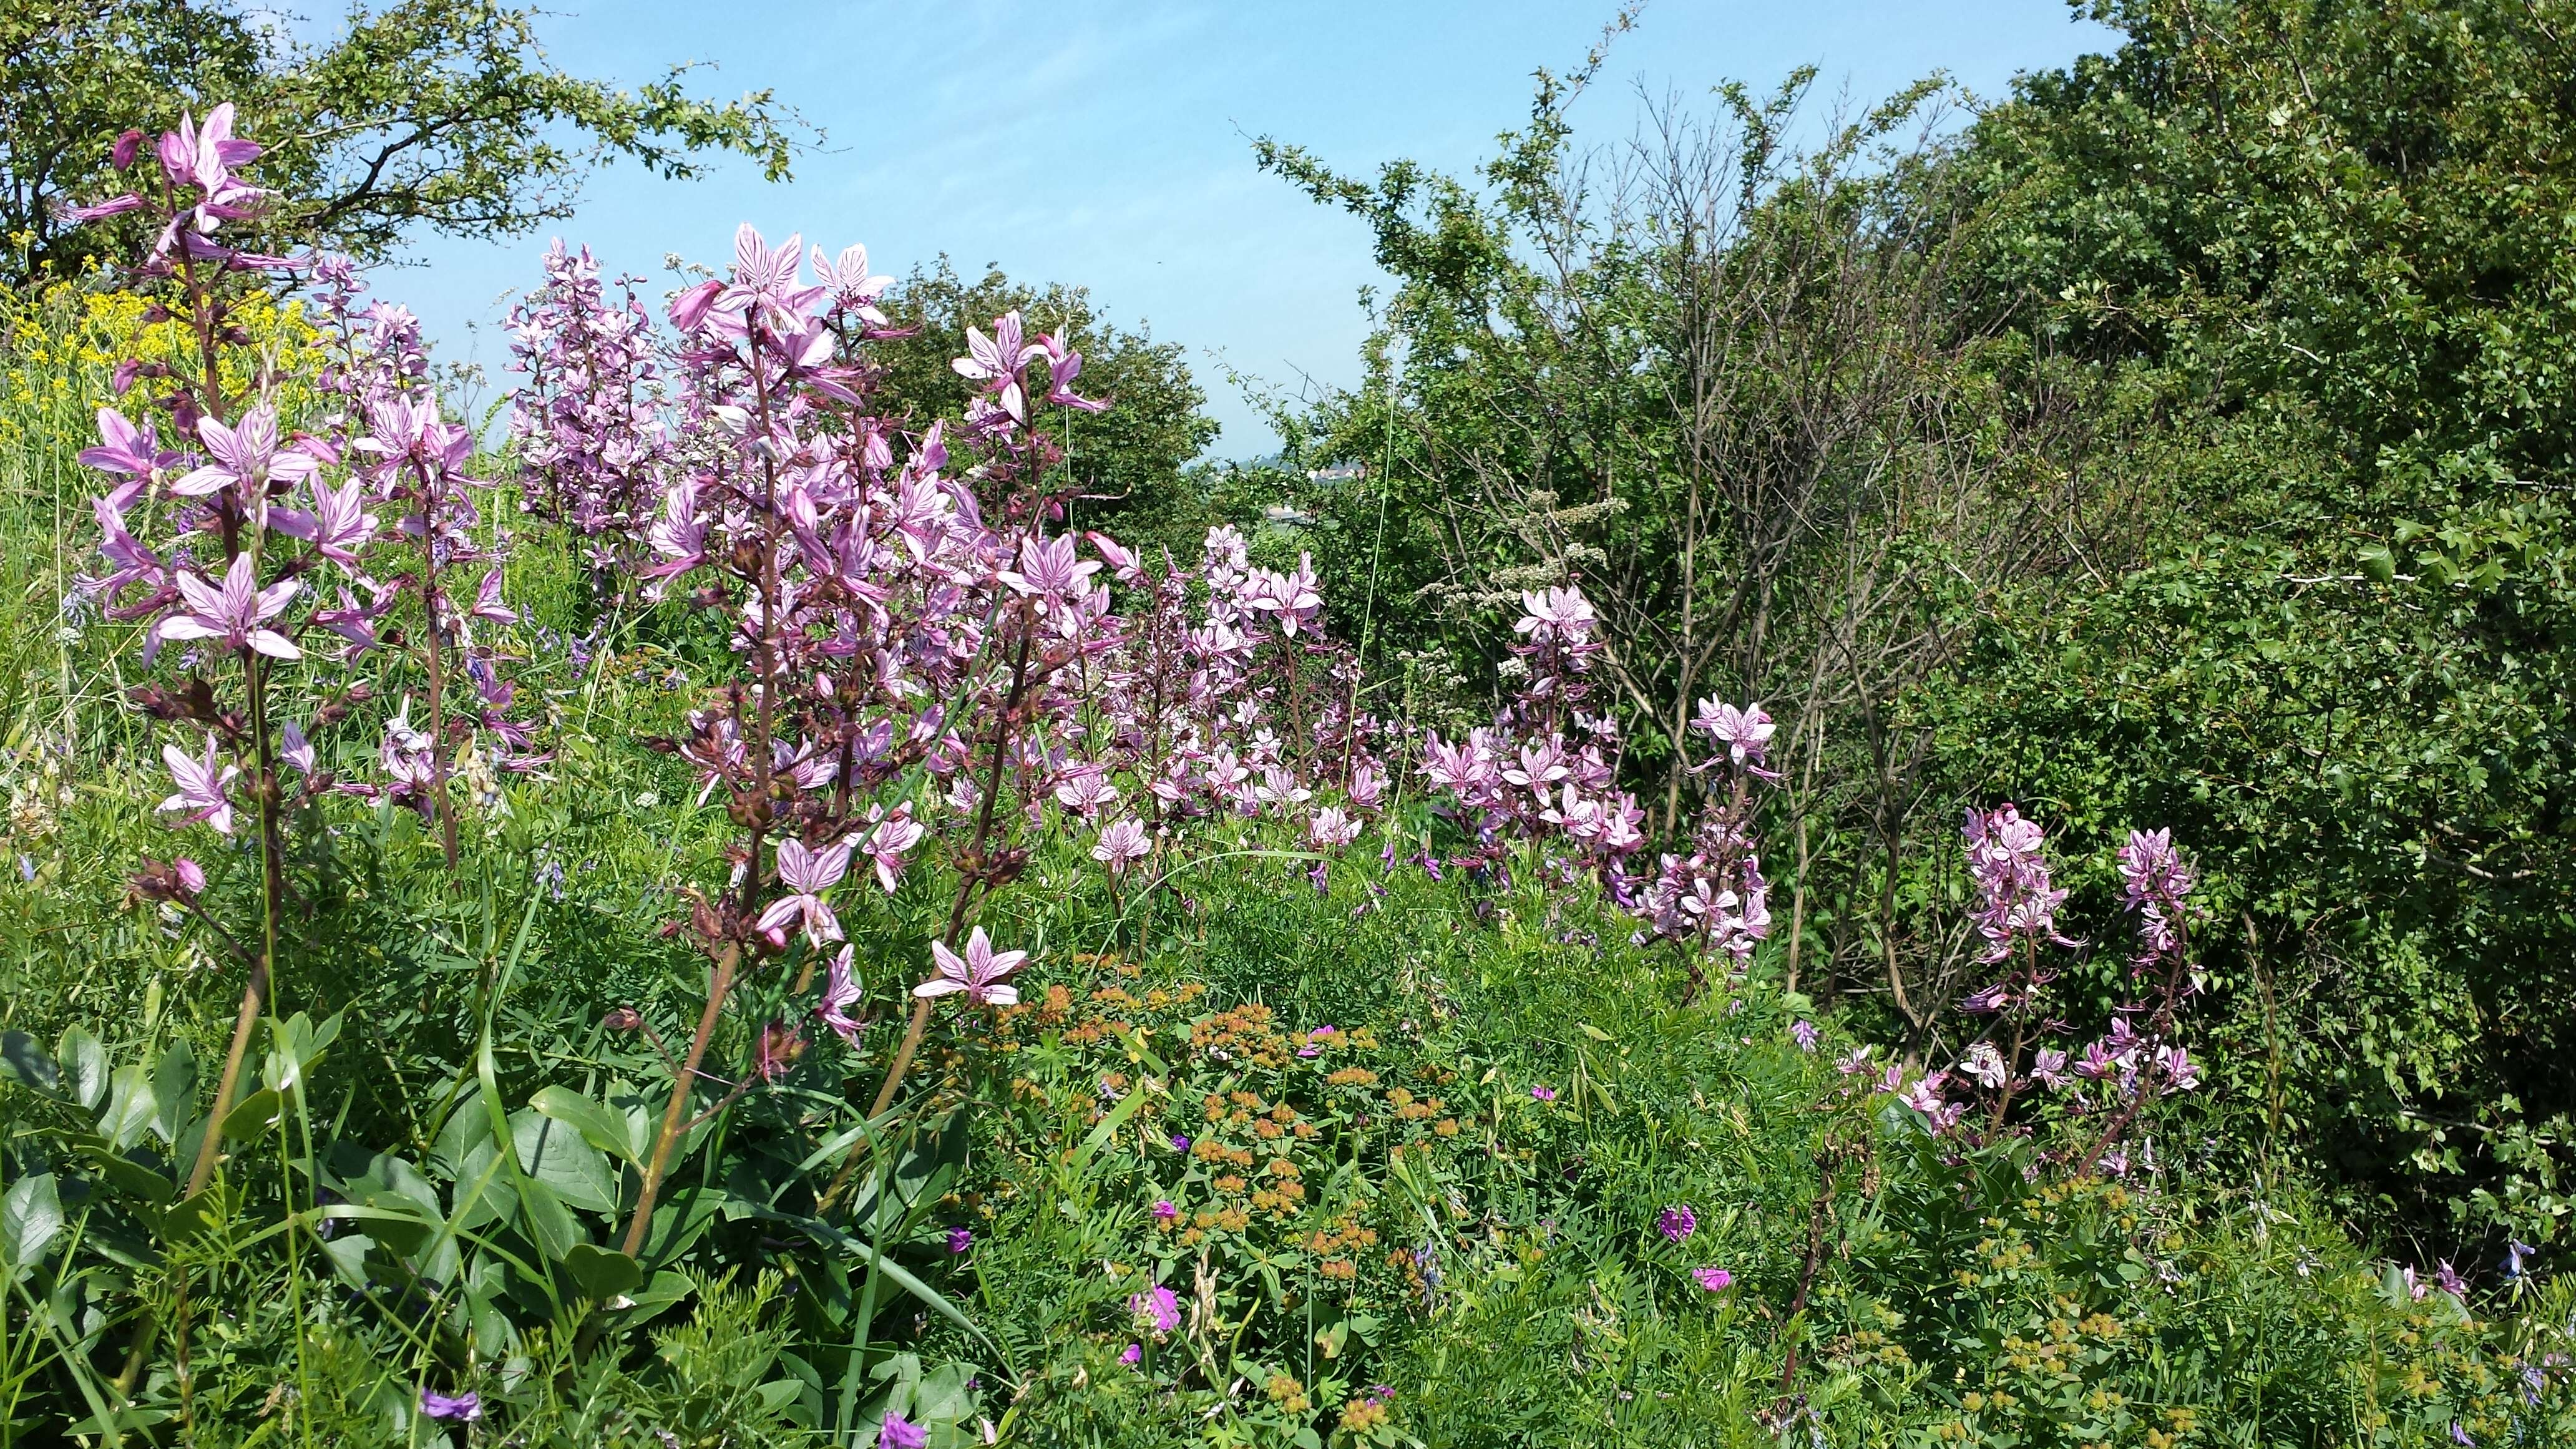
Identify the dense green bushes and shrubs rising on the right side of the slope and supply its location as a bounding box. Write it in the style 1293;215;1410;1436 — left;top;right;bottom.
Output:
1265;0;2576;1258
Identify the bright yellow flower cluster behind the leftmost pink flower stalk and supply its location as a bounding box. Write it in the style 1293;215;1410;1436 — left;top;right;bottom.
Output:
0;281;327;449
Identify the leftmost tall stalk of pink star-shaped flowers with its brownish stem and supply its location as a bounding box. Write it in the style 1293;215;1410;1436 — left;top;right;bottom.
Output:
72;105;353;1194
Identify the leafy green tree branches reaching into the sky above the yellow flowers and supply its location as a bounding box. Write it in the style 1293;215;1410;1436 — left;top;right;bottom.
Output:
0;0;809;283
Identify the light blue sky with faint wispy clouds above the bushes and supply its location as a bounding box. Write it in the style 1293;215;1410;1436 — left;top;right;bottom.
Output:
379;0;2112;456
